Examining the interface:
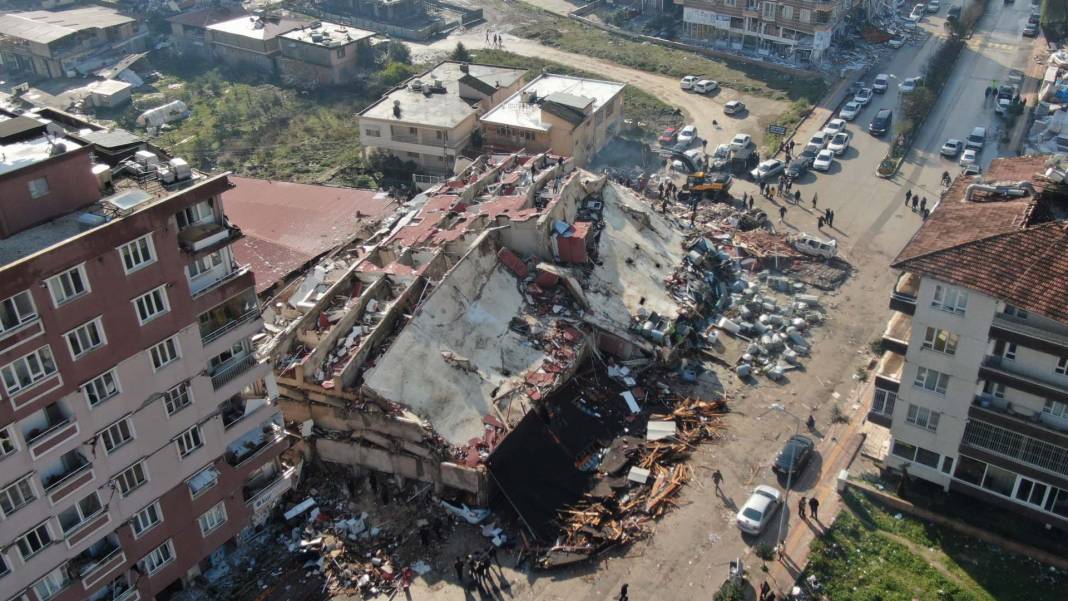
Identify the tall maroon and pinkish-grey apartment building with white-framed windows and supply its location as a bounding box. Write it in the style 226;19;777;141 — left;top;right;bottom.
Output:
0;116;296;601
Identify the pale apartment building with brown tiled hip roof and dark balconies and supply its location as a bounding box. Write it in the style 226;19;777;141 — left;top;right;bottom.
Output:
868;157;1068;531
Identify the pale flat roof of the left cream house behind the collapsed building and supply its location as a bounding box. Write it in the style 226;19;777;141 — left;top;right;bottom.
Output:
360;61;527;128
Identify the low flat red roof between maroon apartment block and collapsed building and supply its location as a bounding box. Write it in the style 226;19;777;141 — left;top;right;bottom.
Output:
222;175;396;291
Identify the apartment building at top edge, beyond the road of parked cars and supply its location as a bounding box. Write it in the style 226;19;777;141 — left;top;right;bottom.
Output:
677;0;853;63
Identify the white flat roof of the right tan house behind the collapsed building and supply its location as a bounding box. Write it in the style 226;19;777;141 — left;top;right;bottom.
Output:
482;74;626;131
